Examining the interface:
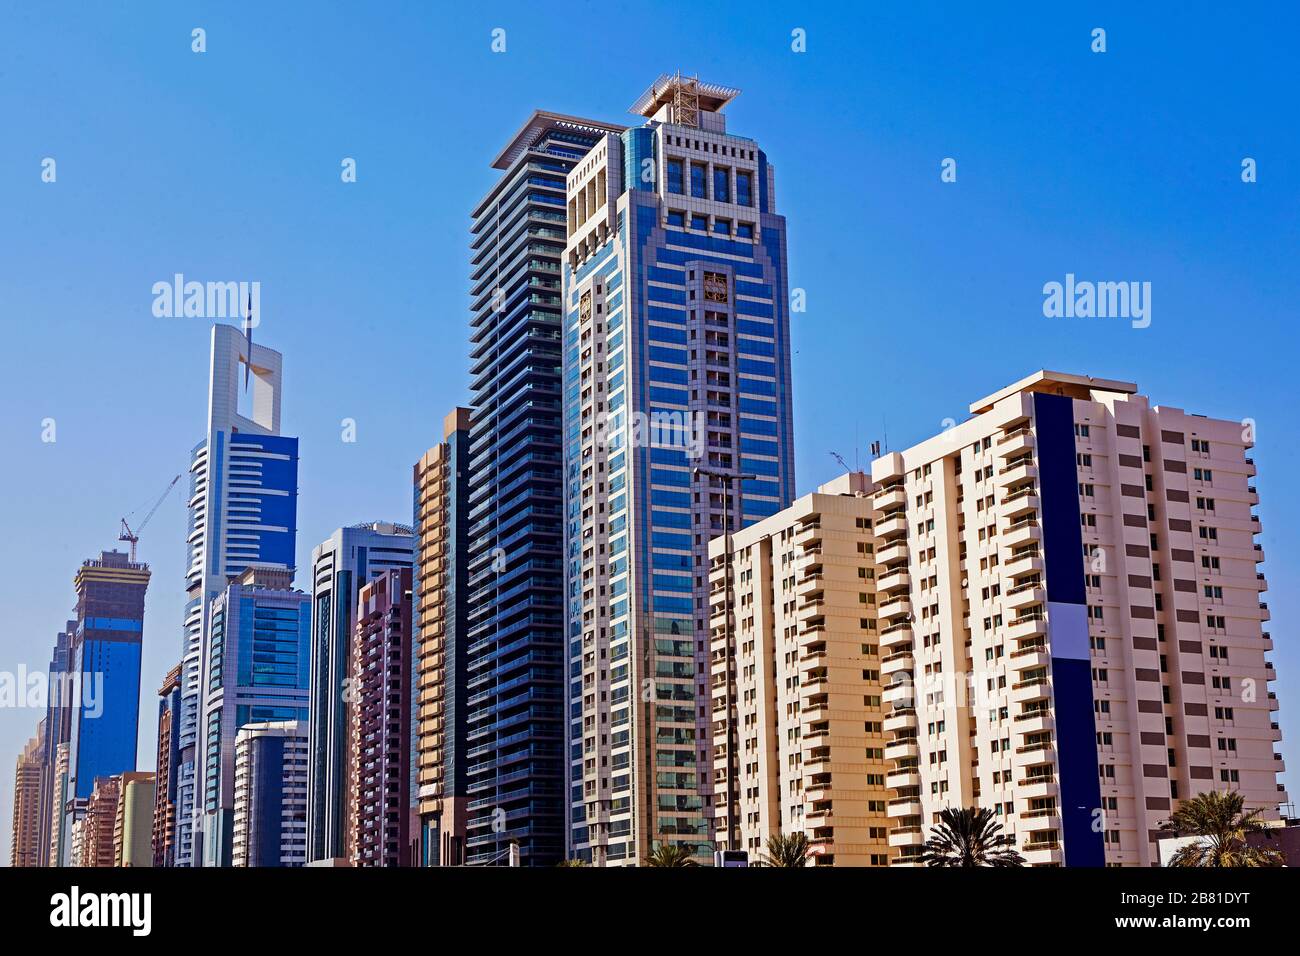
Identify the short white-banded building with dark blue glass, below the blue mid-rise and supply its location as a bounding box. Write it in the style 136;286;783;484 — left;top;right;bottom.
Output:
231;721;308;866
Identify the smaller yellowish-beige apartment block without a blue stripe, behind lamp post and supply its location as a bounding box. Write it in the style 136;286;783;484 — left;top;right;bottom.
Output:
709;473;891;866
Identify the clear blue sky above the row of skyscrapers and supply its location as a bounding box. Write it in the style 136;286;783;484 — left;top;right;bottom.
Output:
0;0;1300;861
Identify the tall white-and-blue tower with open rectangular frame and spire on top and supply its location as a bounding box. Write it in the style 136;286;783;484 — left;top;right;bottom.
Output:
176;325;298;866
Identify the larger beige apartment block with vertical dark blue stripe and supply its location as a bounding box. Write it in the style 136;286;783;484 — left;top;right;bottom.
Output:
872;372;1286;866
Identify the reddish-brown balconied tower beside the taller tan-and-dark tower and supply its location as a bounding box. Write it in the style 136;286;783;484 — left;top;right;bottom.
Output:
350;567;413;866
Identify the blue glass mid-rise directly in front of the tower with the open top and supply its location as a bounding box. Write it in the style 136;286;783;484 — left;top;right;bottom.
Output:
196;567;311;866
